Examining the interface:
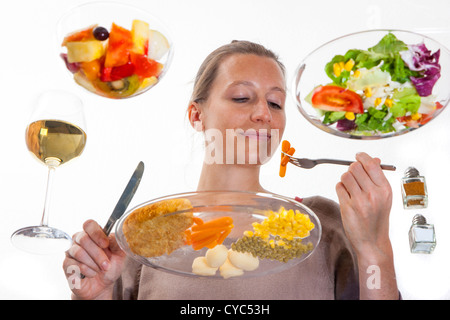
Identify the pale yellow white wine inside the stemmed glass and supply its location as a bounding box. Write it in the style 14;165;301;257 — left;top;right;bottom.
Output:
25;120;86;164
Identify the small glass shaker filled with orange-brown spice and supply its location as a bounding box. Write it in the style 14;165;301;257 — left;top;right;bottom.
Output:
402;167;428;209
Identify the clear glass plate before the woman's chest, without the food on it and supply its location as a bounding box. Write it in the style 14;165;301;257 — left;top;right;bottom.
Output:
116;191;322;279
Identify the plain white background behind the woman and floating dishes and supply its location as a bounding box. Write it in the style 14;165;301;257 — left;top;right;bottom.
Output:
0;0;450;299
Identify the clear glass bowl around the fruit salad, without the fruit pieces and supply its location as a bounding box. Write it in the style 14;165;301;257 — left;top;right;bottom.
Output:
56;1;173;99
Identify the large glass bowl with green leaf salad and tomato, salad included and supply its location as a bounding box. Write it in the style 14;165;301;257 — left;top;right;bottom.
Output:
292;30;450;139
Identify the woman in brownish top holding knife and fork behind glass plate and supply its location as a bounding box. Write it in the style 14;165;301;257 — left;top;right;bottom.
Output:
63;41;399;300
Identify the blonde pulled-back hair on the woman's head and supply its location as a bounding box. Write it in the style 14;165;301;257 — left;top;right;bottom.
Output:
190;40;285;103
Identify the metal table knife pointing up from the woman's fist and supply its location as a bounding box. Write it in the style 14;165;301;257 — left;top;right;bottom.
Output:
103;161;144;236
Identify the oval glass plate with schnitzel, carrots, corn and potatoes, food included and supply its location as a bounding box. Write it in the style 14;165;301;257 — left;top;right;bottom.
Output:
115;191;322;279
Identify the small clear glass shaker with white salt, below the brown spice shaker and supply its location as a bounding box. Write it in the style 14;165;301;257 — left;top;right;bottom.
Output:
409;214;436;253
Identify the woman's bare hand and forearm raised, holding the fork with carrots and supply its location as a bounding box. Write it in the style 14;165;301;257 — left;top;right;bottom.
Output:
336;153;399;300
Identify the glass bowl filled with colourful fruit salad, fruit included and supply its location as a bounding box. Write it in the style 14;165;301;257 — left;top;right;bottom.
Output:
57;2;173;99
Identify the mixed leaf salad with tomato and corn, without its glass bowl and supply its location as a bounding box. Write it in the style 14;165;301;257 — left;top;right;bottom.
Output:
305;33;442;135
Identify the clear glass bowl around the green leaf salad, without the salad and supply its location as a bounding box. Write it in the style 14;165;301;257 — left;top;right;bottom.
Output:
293;30;450;139
